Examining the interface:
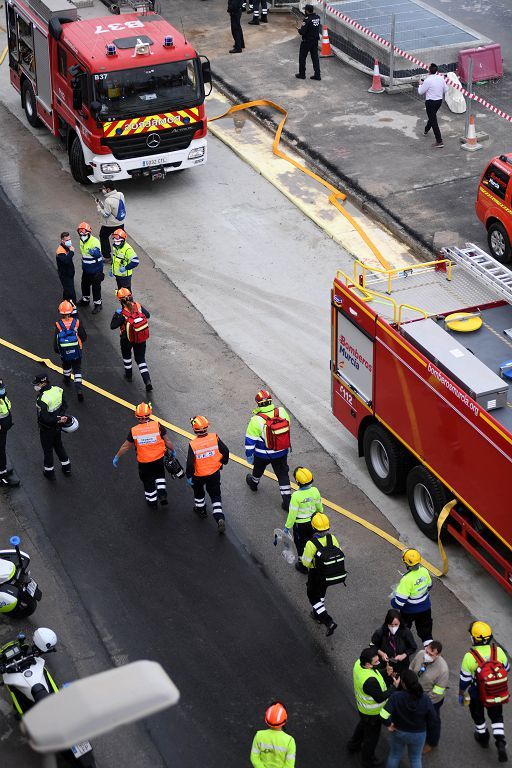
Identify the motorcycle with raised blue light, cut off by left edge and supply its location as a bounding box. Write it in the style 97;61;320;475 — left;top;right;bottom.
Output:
0;536;42;618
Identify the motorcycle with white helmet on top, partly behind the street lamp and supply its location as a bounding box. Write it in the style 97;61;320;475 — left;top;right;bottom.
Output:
0;627;96;768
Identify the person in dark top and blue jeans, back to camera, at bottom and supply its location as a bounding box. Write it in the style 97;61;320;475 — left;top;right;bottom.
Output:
380;669;437;768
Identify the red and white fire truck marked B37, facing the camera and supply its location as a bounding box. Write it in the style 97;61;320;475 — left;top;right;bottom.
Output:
5;0;211;184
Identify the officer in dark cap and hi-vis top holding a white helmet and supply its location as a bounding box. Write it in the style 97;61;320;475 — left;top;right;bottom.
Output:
32;373;71;480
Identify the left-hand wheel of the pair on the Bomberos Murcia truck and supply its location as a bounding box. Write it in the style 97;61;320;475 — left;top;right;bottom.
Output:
363;424;408;494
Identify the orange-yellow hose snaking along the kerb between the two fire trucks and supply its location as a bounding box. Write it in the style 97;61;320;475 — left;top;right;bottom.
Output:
208;99;392;269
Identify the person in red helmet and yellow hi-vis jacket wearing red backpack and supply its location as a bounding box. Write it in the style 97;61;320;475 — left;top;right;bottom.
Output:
245;389;292;512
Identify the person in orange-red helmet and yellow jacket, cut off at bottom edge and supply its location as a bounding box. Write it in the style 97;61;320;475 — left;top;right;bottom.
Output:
251;701;297;768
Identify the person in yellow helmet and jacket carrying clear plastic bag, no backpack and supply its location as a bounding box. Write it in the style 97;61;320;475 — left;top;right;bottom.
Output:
284;467;324;573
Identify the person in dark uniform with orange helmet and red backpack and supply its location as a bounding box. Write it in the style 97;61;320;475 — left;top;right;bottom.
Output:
110;288;153;392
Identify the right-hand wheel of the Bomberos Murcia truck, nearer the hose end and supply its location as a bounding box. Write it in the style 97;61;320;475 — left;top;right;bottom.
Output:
407;465;448;541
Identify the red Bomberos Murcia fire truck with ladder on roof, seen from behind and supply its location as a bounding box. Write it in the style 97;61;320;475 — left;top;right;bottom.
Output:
331;243;512;593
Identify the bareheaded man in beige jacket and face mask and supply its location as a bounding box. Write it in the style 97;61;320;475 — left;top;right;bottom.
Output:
411;640;450;754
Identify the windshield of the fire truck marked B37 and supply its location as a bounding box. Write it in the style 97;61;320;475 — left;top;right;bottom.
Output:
92;59;202;120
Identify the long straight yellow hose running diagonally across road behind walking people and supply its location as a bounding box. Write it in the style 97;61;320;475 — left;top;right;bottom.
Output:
0;339;444;576
